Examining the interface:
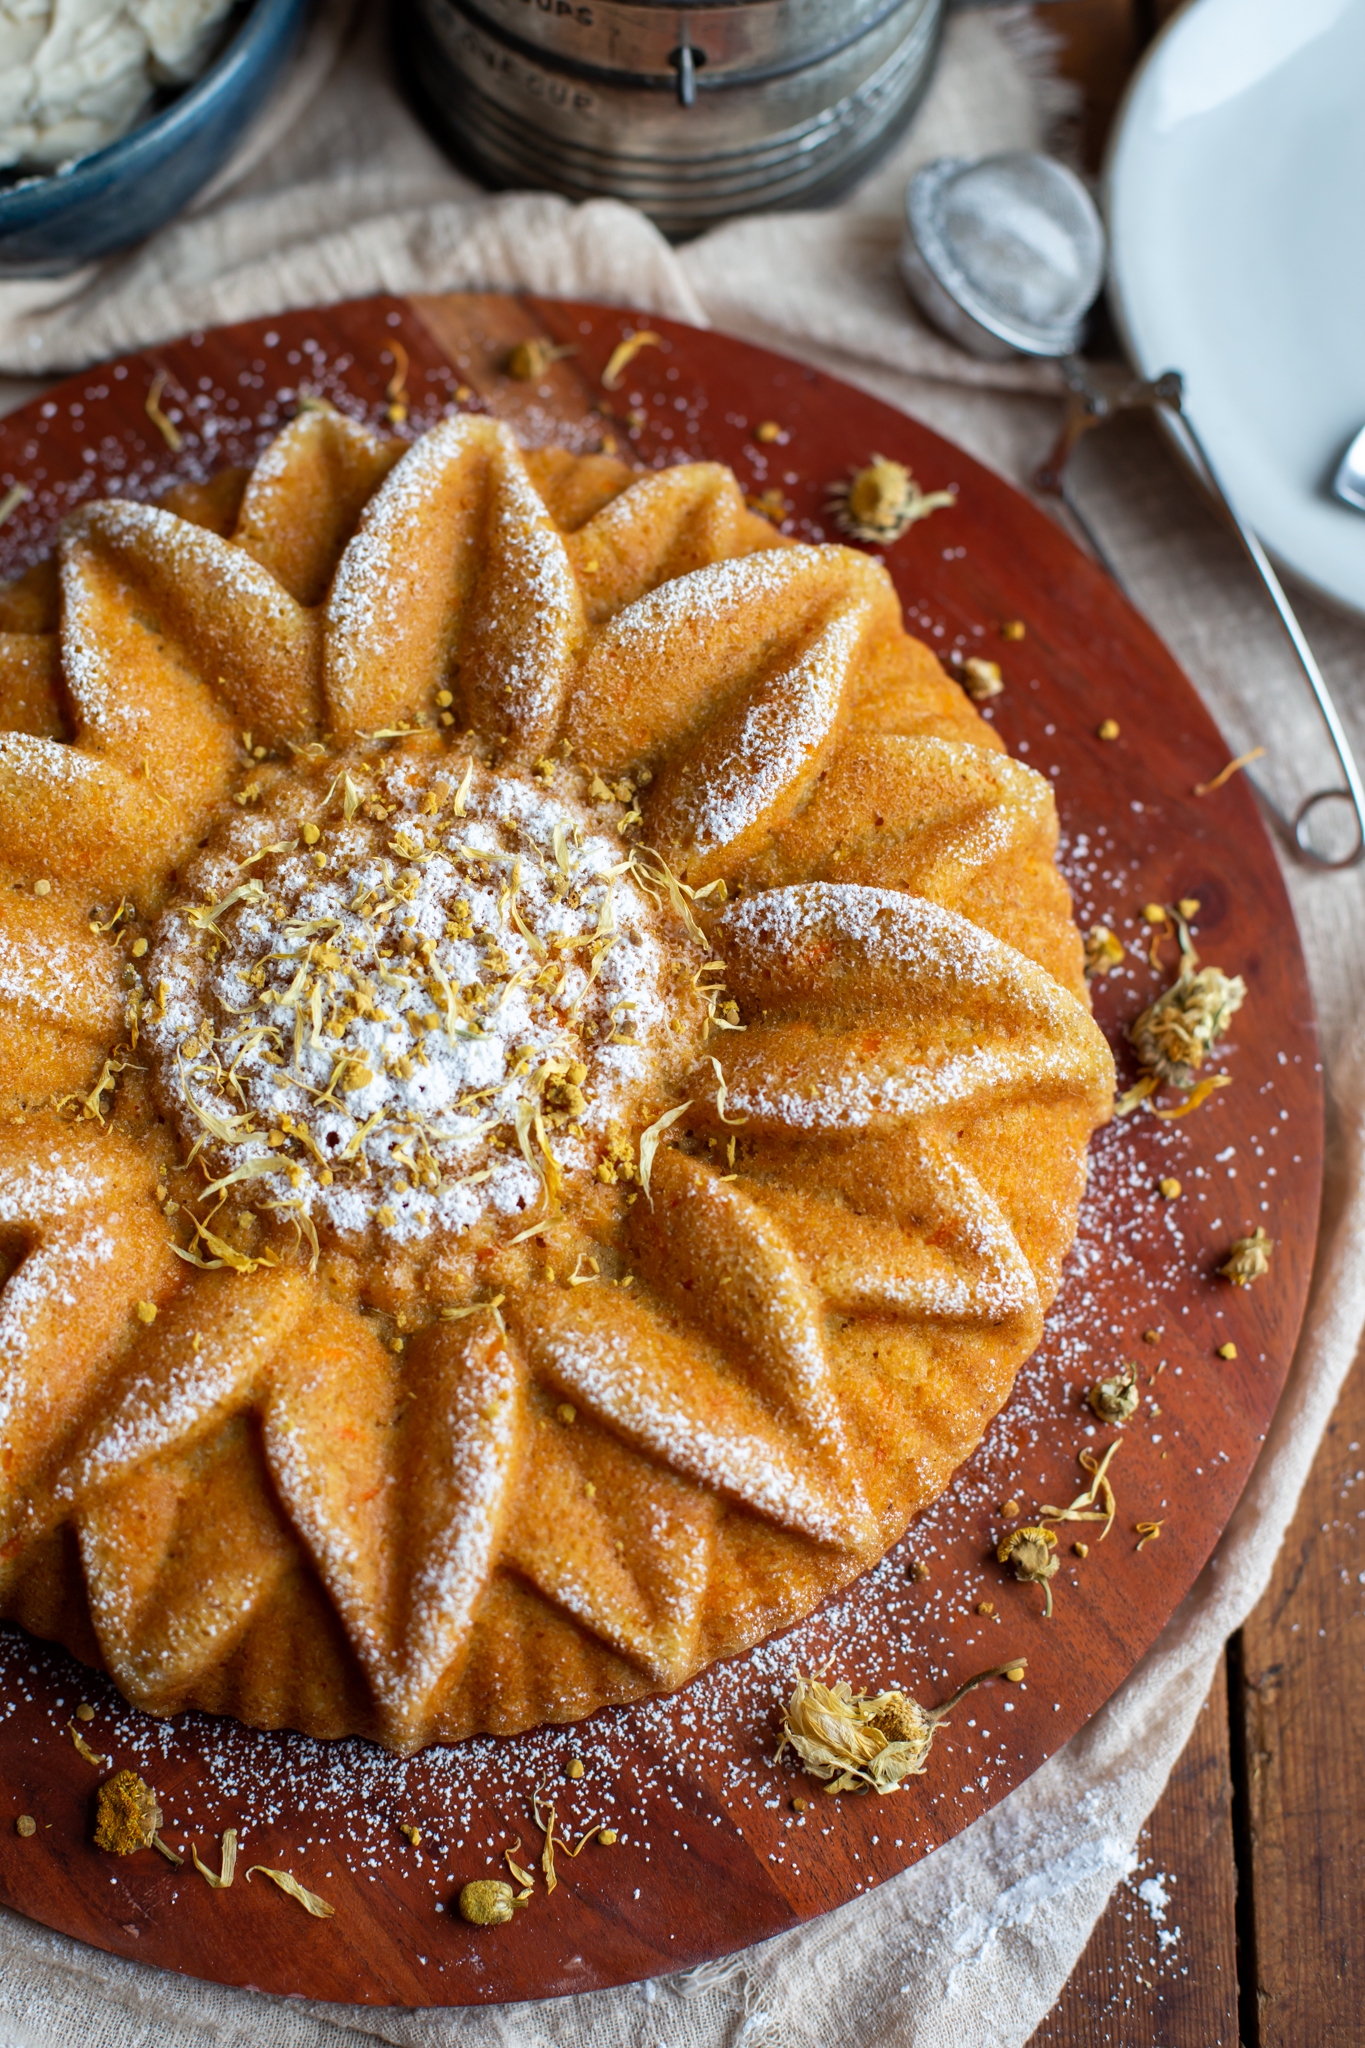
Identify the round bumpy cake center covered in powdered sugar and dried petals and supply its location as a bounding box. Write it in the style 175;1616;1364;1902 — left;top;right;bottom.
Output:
145;743;714;1243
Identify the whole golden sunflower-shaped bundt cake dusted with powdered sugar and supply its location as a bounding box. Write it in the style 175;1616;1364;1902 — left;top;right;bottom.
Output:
0;408;1113;1751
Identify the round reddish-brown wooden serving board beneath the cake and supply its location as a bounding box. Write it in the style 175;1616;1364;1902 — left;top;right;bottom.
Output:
0;297;1322;2005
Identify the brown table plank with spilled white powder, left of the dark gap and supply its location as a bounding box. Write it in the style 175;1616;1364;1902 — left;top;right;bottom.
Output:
1029;1661;1244;2048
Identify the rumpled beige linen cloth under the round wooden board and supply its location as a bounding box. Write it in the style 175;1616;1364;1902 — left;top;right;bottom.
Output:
0;6;1365;2048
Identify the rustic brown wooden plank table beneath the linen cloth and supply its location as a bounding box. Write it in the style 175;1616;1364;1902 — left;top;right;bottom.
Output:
1029;0;1365;2048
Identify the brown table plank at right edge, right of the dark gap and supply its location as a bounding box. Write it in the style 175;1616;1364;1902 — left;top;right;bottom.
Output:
1240;1327;1365;2048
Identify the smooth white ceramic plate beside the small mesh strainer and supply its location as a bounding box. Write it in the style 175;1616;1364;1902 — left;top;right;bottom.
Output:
1105;0;1365;616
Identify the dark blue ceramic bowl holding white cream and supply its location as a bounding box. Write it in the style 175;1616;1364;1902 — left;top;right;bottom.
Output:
0;0;307;276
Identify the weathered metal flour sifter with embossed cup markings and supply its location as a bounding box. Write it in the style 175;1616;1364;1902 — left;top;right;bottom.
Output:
397;0;945;236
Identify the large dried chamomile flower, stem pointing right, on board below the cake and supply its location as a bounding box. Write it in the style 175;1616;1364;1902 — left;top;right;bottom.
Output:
778;1657;1023;1792
